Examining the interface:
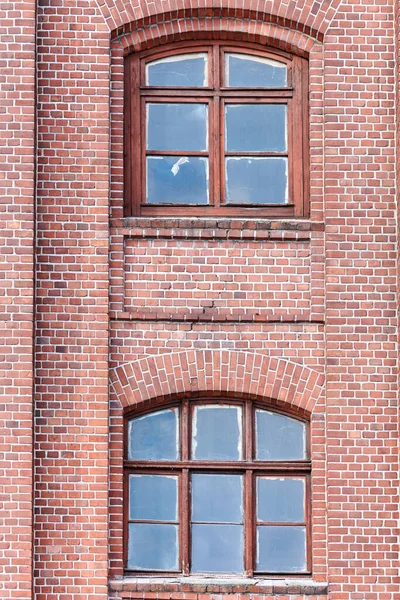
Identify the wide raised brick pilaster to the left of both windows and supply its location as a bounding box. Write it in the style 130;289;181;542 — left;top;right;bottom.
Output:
35;0;109;600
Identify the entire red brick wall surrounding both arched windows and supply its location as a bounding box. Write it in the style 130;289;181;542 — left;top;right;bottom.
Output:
0;0;399;600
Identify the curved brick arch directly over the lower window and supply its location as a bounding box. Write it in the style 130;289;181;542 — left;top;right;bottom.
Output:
110;350;324;415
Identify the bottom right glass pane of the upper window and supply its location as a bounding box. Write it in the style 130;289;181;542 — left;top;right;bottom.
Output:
226;156;288;204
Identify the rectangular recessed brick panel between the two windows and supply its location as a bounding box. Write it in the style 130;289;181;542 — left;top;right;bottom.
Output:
124;239;310;320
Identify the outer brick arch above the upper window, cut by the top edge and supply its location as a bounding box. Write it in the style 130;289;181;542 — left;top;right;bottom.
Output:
99;0;340;41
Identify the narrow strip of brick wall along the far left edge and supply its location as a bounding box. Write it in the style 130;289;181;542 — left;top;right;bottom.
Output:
0;0;35;600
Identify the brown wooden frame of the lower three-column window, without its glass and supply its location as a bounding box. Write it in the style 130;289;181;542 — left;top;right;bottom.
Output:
124;397;312;579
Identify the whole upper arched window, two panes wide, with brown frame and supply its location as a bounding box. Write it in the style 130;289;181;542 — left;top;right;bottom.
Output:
125;42;308;217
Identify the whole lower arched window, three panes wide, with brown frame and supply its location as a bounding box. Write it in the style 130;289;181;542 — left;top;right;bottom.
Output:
124;399;311;576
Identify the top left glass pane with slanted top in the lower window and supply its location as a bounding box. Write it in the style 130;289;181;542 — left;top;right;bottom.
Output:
128;408;179;460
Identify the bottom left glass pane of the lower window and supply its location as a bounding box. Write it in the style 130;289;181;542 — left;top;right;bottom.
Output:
128;523;178;571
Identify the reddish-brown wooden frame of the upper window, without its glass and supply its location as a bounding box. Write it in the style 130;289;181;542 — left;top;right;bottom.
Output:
124;41;309;218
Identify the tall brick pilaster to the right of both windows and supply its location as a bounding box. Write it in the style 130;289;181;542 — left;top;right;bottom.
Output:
324;0;398;600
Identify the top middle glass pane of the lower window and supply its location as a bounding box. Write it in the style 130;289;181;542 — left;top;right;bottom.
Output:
192;406;242;460
